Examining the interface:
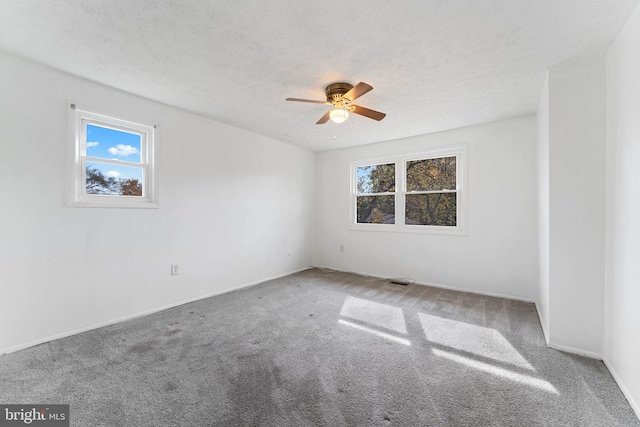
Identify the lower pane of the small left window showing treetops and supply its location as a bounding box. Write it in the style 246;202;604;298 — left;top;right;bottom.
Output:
85;162;143;197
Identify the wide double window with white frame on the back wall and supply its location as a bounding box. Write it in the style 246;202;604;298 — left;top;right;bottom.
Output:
351;145;465;234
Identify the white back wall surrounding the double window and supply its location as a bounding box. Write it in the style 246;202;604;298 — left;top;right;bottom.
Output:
316;116;537;301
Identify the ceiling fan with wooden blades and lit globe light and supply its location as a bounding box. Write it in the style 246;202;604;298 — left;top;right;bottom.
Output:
286;82;386;125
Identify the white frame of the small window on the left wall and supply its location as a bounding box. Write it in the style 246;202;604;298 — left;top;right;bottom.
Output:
67;102;159;209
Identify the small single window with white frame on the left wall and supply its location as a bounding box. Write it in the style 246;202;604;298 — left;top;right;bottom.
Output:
69;104;158;208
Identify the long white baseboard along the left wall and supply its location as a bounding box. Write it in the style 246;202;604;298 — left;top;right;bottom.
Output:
0;267;311;355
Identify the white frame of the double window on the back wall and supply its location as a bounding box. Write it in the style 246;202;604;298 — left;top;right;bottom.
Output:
349;144;467;235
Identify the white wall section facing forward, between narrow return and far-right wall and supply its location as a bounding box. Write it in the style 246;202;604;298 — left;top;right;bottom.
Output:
548;55;606;357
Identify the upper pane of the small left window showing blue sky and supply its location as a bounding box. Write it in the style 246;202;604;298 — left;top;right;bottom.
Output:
86;124;141;163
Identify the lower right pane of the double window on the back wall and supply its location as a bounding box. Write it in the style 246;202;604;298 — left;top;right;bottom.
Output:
405;193;457;227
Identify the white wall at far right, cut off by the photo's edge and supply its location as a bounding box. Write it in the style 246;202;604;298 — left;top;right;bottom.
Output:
604;0;640;417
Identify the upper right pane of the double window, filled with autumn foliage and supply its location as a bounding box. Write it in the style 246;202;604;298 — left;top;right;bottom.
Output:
407;156;456;192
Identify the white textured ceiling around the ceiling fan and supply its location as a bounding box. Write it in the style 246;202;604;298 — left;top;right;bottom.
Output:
0;0;638;150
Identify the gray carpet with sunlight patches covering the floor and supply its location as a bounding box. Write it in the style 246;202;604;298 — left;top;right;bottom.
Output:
0;269;640;427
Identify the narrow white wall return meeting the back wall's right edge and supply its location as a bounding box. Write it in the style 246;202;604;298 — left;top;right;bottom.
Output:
536;72;549;340
